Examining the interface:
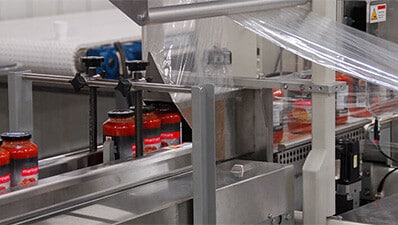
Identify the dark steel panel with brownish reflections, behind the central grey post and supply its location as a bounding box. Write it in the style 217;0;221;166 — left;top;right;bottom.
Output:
178;89;260;161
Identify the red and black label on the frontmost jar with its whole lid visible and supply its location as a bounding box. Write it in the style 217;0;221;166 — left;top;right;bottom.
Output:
11;157;39;190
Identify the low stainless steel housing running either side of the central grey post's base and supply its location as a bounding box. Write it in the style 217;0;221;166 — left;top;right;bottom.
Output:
29;160;294;224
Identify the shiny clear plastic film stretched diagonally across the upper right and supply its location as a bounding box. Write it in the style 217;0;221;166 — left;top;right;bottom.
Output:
231;7;398;90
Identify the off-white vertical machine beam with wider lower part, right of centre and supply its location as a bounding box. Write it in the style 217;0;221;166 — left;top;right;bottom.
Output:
303;0;336;224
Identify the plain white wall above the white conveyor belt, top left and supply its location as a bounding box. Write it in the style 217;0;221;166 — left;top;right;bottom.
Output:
0;0;113;20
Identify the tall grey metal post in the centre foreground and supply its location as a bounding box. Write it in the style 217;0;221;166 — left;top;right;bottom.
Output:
192;84;216;224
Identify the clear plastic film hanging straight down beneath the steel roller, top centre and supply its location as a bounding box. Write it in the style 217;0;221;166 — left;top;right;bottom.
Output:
144;0;233;103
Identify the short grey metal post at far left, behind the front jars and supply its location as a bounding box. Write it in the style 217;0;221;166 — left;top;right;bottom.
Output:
8;71;33;134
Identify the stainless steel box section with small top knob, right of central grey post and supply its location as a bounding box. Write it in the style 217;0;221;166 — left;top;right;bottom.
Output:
217;161;294;224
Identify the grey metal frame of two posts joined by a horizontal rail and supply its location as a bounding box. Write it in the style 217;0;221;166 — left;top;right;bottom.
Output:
8;72;216;224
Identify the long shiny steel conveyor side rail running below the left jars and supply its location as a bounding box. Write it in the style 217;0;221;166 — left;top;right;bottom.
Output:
0;144;191;223
